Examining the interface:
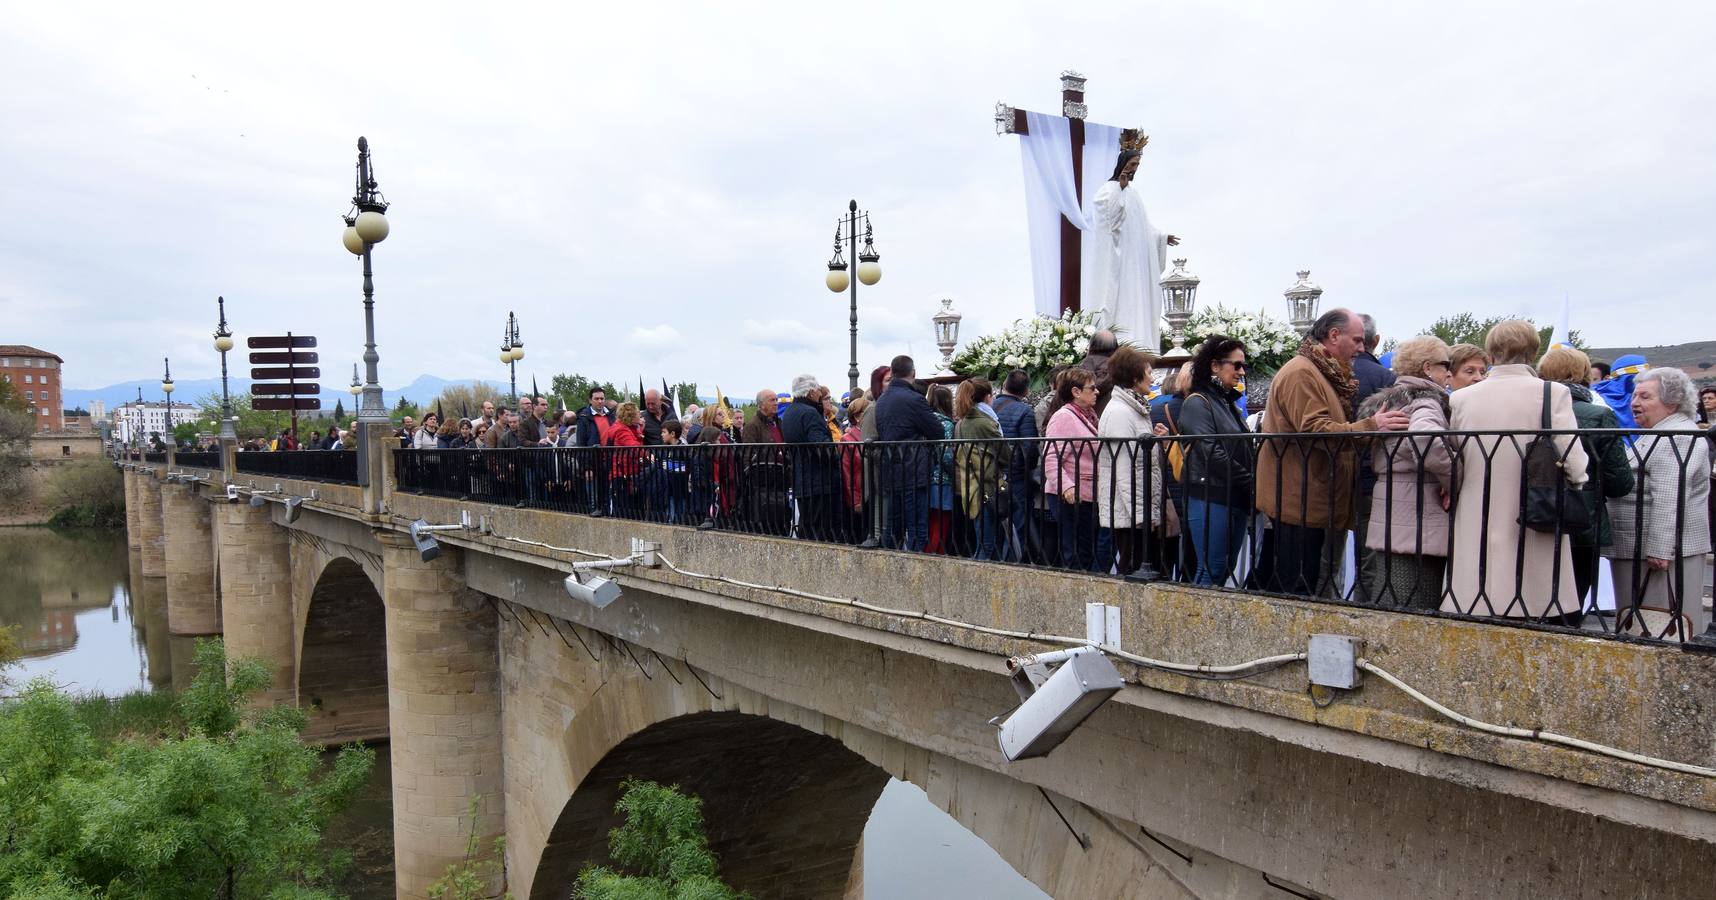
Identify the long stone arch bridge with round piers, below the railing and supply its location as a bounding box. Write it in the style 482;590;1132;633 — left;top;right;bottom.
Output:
125;450;1716;900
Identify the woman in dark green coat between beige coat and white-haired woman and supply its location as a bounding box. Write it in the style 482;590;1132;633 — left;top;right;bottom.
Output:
1538;345;1632;608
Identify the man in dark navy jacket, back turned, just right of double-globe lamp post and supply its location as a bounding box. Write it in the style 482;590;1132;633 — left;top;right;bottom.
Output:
875;356;942;550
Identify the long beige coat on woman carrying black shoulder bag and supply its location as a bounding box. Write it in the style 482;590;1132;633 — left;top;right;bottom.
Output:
1441;366;1587;618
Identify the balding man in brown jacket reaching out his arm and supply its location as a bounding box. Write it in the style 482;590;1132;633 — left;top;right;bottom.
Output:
1256;309;1409;594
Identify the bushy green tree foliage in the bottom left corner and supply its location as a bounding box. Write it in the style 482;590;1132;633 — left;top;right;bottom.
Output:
0;641;374;900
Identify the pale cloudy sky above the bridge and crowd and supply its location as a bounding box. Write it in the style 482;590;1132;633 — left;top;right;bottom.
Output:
0;0;1716;393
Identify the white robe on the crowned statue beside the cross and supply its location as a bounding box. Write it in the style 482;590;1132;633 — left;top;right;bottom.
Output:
1085;182;1169;352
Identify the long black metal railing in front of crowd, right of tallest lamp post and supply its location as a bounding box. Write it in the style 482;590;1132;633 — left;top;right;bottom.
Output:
392;431;1711;641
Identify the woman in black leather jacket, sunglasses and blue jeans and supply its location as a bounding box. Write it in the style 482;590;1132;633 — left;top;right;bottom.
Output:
1179;335;1253;586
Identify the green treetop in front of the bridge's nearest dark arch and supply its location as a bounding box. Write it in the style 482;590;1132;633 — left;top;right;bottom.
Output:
571;778;750;900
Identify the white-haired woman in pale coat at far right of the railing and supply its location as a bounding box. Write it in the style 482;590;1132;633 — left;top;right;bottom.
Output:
1603;369;1711;641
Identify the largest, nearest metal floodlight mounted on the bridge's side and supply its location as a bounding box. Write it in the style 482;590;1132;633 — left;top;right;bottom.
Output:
992;646;1121;763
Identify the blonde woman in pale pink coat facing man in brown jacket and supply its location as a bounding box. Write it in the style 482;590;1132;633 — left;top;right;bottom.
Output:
1359;335;1453;610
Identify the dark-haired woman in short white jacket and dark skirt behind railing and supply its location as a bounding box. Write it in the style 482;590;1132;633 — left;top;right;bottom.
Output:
1097;345;1163;575
